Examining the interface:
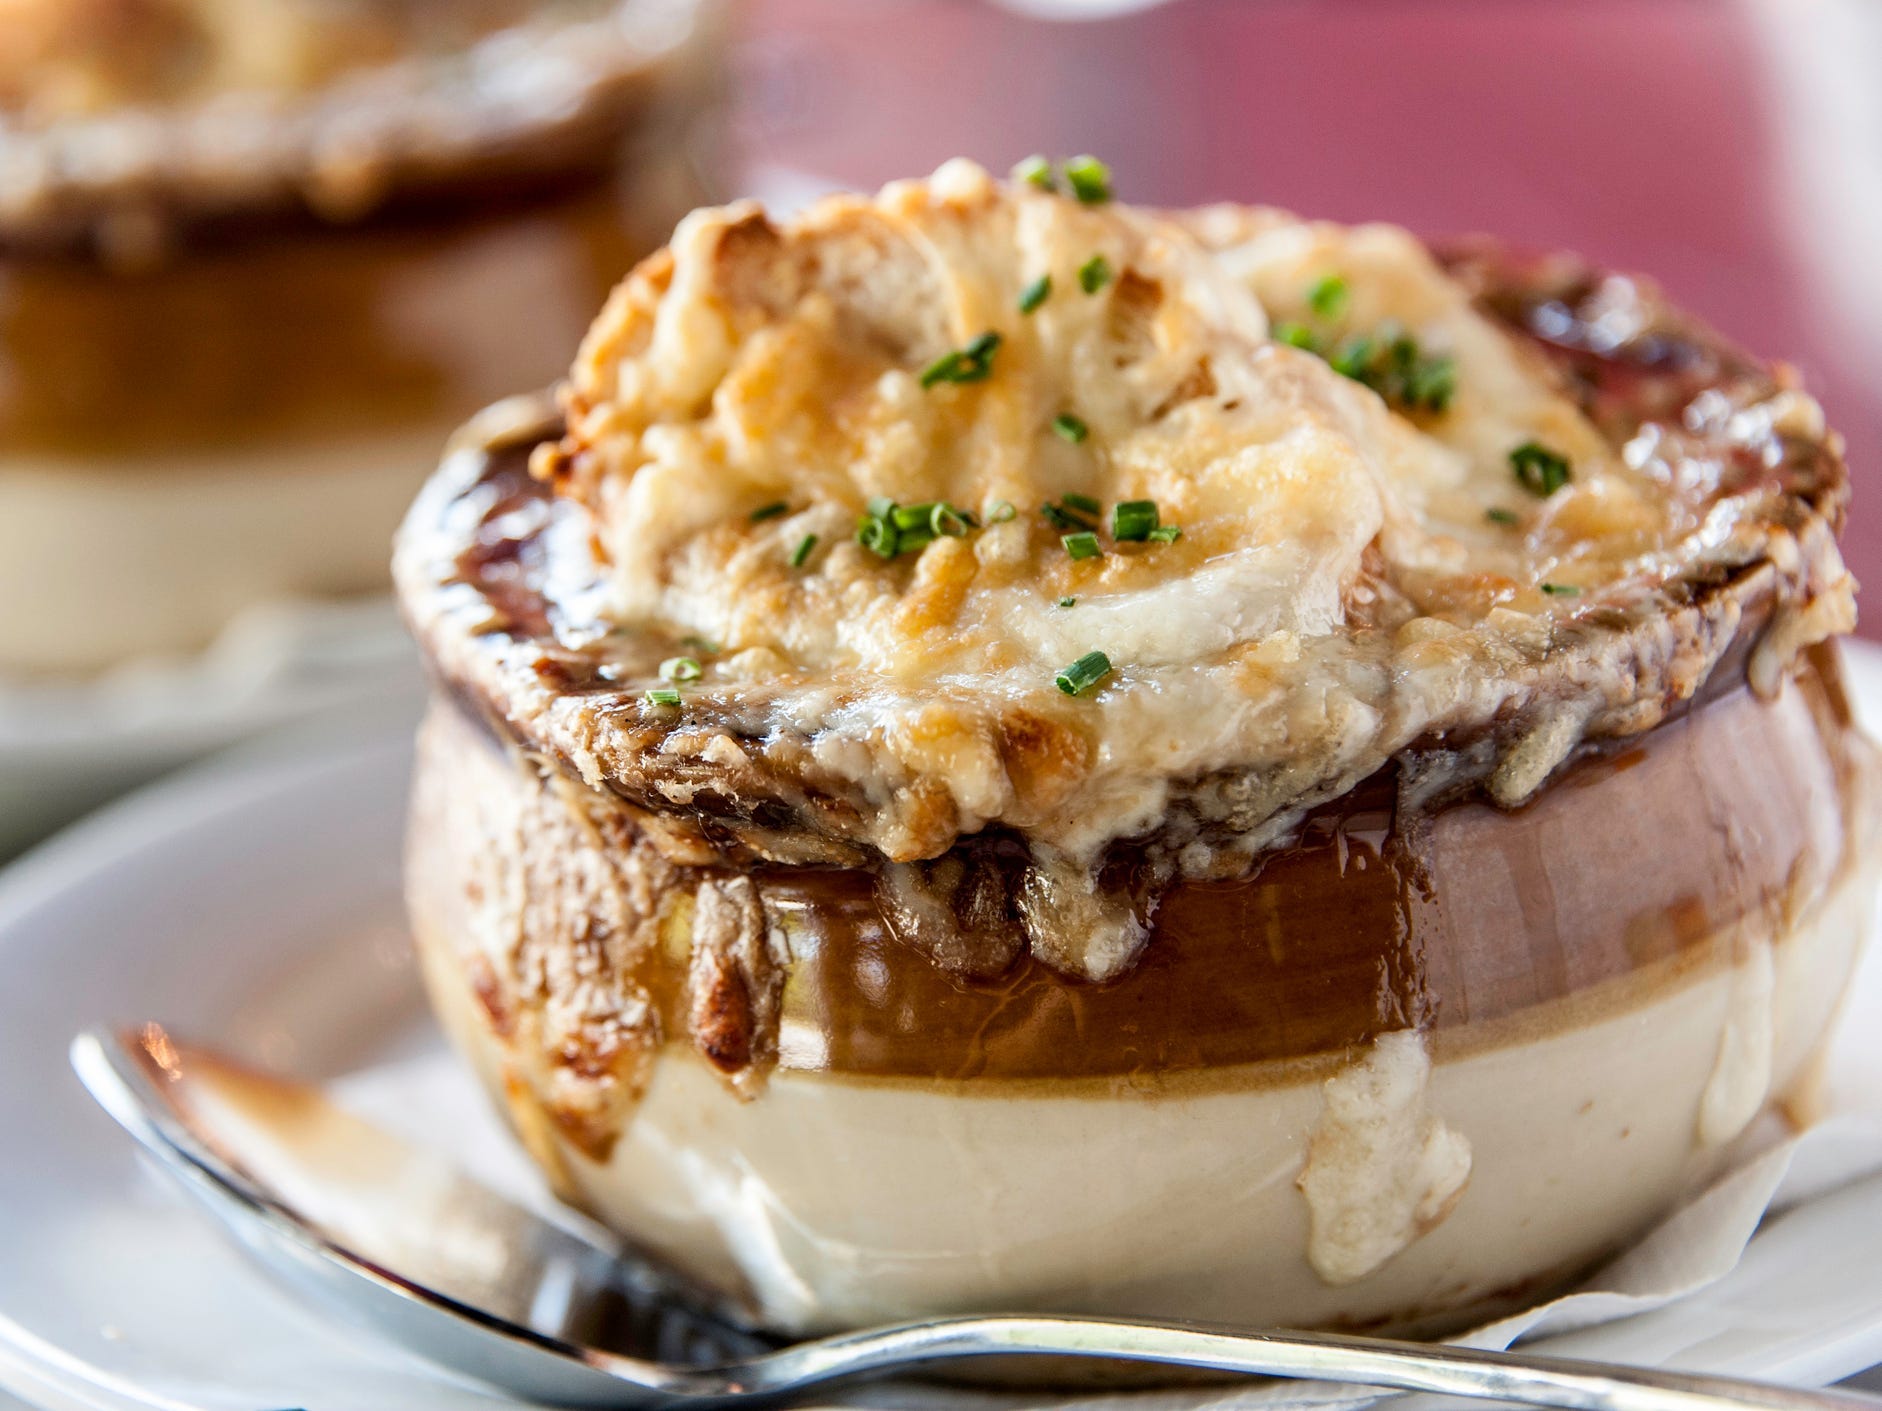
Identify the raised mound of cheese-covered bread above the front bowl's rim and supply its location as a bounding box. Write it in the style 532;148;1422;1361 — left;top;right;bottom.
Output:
572;164;1666;677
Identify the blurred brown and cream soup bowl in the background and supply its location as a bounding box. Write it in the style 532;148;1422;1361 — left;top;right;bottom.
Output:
0;0;713;675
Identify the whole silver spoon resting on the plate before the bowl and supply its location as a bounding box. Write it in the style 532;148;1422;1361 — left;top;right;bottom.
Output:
72;1025;1882;1411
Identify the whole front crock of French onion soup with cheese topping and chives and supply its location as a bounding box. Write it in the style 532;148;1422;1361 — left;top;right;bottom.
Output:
395;162;1876;1332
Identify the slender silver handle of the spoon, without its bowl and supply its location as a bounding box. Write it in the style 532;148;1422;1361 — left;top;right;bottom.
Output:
738;1317;1882;1411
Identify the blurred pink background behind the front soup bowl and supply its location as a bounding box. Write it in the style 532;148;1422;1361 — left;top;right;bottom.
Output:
734;0;1882;634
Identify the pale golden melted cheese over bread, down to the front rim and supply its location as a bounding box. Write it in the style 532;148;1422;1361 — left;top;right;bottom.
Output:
538;162;1829;880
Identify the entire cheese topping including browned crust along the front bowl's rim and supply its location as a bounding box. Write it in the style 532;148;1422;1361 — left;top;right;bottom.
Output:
399;162;1854;978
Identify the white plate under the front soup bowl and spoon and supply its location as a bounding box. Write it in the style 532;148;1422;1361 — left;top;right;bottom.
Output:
0;647;1882;1411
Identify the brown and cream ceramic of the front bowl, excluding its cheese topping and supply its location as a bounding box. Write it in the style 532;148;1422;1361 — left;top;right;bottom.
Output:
399;165;1874;1332
